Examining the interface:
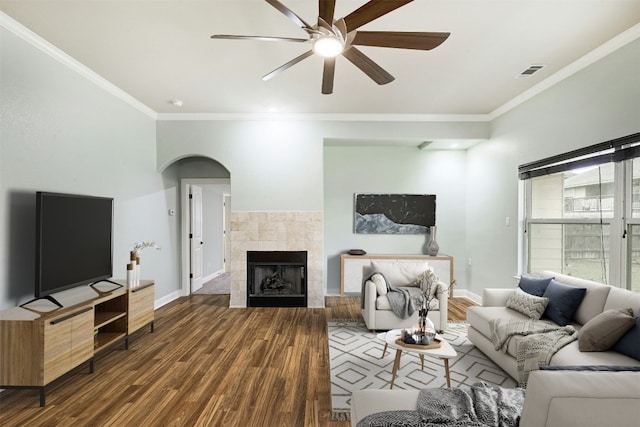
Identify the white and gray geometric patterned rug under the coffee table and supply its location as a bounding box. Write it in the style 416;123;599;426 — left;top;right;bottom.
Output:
327;321;516;420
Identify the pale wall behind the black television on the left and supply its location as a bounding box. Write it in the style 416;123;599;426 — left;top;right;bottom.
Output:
0;28;178;308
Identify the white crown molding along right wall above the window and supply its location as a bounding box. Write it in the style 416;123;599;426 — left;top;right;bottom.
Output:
488;24;640;120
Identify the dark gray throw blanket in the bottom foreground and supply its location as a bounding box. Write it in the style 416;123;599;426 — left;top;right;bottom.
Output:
357;382;524;427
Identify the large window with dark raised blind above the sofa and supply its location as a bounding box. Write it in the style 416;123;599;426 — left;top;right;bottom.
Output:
520;134;640;291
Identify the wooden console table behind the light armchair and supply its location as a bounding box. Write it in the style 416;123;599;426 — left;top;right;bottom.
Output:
340;254;454;297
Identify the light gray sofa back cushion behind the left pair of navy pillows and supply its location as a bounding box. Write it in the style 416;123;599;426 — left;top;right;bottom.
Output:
541;271;612;325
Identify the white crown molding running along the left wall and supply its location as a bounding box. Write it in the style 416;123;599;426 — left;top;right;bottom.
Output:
0;11;158;120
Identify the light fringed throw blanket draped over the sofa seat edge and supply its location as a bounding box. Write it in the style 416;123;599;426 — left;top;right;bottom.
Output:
489;319;578;387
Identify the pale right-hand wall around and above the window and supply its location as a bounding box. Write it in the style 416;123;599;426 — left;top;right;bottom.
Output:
466;40;640;295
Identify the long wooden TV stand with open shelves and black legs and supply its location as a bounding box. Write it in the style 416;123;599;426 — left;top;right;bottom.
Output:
0;280;155;406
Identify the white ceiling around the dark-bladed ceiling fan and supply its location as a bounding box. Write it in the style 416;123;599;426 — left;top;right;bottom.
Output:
0;0;640;115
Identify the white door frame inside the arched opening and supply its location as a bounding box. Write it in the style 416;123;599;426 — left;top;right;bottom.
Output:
180;178;231;296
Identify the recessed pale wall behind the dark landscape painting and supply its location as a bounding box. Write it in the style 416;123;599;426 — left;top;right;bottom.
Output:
324;146;466;294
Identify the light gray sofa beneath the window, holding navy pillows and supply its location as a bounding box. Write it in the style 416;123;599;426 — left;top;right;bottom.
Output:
467;271;640;380
